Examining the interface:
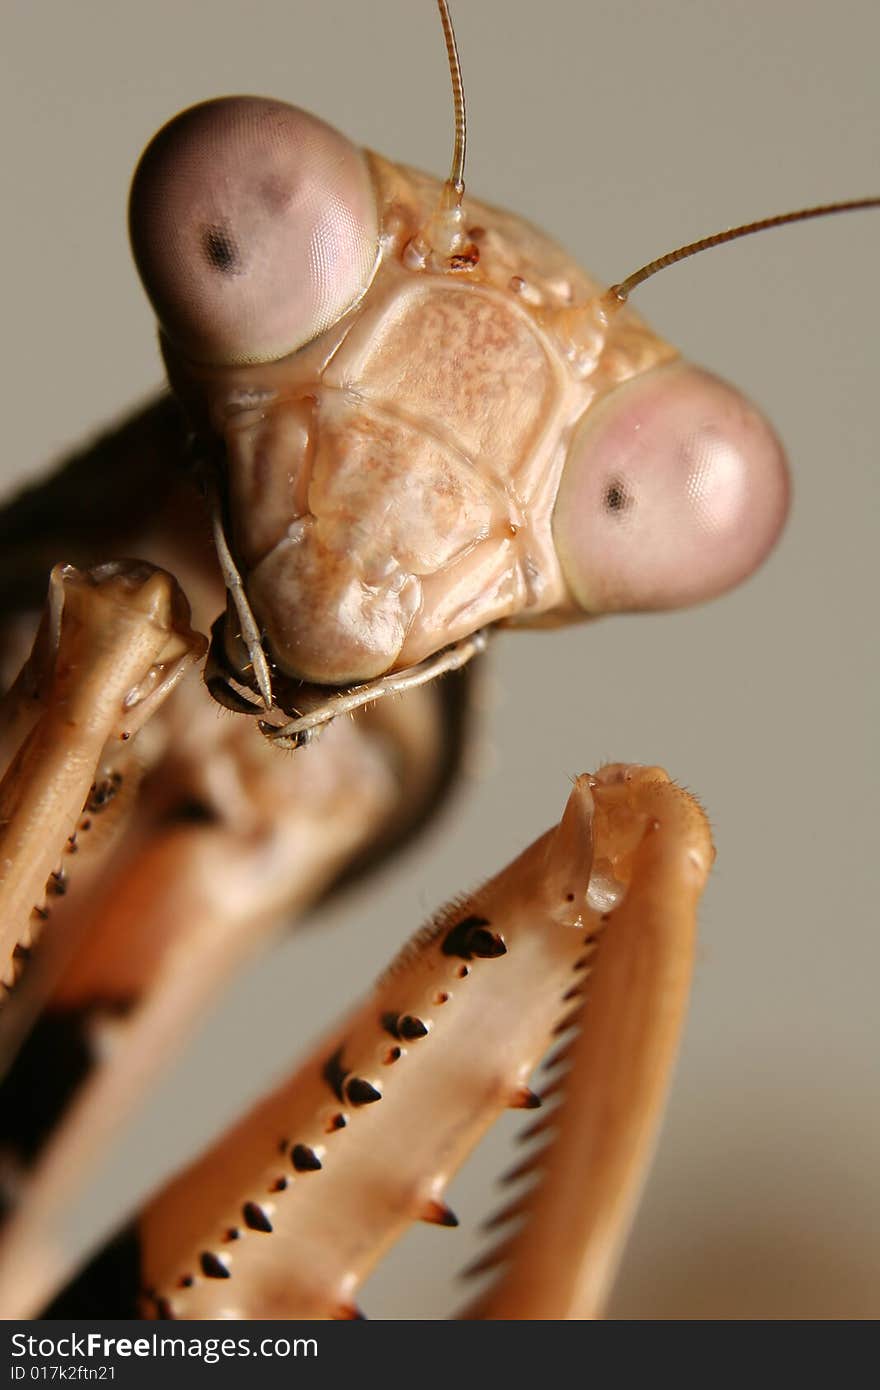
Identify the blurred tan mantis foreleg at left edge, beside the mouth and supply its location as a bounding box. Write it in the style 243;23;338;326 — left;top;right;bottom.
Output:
0;562;206;986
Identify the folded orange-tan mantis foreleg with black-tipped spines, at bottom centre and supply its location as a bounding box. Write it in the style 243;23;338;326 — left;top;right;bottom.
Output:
42;769;712;1318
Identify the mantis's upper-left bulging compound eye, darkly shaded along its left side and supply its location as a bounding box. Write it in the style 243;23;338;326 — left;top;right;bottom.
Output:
129;97;378;366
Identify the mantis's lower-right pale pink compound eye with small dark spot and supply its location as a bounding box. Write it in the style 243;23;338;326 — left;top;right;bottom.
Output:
553;363;788;613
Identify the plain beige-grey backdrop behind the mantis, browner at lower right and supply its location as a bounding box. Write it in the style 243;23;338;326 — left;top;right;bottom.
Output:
0;0;880;1318
